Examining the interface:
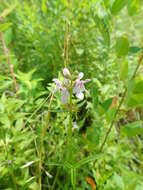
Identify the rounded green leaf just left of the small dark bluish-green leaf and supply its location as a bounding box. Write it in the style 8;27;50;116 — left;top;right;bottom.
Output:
116;36;129;57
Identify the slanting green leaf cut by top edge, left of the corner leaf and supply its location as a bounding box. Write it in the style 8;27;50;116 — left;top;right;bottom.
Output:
111;0;128;15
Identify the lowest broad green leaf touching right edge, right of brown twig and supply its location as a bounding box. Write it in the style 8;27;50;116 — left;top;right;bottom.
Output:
121;121;143;137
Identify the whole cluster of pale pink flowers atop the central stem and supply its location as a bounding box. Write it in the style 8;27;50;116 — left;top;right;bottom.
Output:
53;68;90;104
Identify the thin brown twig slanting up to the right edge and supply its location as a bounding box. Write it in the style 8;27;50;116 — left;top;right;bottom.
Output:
99;54;143;152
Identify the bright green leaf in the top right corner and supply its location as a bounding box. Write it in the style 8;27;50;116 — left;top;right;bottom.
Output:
128;0;141;16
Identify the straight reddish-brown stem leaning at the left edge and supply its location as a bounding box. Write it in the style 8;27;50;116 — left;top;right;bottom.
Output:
0;32;18;95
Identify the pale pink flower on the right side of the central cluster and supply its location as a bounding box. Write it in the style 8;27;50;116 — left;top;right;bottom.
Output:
73;72;90;100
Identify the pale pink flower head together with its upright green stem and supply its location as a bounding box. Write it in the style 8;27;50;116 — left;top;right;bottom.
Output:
53;68;90;189
